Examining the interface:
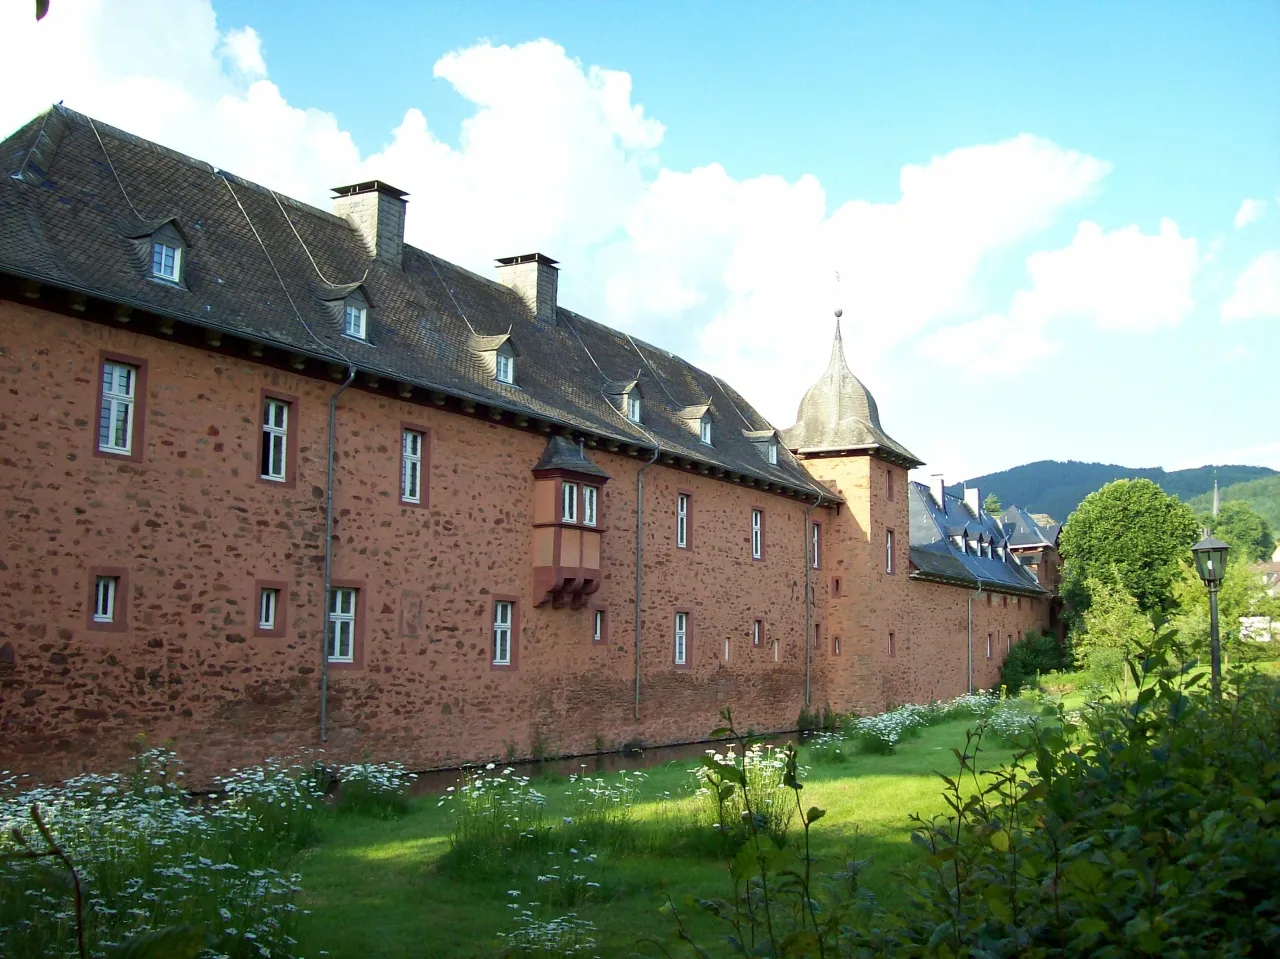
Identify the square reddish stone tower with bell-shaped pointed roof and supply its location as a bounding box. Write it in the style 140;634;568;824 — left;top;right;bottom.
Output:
782;320;923;714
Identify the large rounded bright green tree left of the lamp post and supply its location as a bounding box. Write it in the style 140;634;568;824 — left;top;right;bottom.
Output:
1060;479;1199;617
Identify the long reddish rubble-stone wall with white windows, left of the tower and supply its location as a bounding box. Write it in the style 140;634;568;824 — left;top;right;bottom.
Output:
0;302;819;778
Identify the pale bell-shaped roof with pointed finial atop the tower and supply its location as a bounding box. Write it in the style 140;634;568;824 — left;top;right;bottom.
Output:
782;320;924;469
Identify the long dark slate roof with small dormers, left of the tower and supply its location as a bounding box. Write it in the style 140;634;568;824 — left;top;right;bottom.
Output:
0;106;832;501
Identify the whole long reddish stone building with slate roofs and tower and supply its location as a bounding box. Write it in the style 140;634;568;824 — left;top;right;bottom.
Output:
0;106;1050;776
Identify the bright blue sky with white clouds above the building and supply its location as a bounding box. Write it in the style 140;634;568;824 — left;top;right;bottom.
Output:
0;0;1280;479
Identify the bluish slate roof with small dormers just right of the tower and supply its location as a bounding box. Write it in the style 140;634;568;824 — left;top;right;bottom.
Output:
908;483;1048;597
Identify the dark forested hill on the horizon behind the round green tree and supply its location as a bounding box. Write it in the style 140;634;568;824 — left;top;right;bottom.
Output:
951;460;1277;522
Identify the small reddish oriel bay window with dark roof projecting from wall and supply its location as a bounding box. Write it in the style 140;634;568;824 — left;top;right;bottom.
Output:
534;435;609;609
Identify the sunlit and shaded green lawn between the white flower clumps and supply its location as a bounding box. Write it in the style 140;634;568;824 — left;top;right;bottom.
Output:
294;721;1010;959
